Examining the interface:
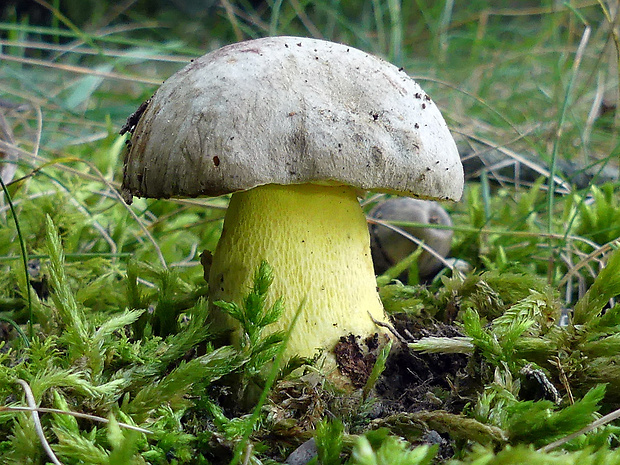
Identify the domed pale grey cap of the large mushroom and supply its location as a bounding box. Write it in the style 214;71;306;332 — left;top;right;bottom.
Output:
122;37;463;200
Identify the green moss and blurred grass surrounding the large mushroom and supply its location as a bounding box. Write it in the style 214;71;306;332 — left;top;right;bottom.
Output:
0;0;620;464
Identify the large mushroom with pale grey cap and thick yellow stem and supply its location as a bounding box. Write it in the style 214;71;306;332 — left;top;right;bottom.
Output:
122;37;463;357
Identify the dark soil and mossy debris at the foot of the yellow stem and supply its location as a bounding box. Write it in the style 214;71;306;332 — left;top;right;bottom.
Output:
213;315;480;461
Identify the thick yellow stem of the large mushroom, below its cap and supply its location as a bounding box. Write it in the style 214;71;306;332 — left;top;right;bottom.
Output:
209;184;385;357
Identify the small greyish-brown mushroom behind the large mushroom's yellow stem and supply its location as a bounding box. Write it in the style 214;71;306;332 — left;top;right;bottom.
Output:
368;197;452;280
